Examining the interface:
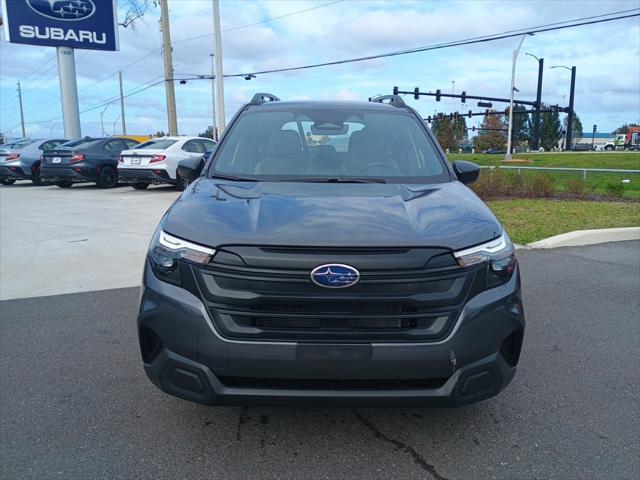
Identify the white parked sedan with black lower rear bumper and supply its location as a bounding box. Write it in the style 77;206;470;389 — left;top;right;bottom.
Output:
118;137;216;190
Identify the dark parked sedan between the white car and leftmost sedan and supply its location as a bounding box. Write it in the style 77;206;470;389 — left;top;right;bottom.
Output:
40;137;139;188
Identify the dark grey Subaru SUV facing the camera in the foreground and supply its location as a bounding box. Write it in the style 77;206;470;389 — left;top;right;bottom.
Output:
138;94;525;406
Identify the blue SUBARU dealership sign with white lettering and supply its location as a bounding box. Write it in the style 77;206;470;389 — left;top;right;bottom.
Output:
2;0;118;50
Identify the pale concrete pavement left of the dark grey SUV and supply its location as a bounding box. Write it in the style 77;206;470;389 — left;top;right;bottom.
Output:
0;182;178;300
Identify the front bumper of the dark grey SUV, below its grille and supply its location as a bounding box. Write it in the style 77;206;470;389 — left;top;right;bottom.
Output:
138;262;525;407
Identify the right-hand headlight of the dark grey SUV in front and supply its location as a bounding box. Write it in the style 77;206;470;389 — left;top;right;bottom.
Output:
453;232;517;288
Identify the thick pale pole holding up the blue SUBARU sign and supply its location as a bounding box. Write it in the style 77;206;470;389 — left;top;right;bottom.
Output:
56;47;82;140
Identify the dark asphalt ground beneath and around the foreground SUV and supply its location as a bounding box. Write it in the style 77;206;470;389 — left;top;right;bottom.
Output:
0;231;640;479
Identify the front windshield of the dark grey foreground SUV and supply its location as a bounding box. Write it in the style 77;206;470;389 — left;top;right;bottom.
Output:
209;107;449;183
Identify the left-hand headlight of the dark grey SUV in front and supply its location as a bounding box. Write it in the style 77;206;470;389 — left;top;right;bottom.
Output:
148;228;216;285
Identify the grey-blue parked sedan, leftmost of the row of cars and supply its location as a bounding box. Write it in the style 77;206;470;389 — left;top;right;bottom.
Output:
0;138;67;185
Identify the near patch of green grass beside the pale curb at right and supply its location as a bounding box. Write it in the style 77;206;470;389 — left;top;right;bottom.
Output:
487;199;640;244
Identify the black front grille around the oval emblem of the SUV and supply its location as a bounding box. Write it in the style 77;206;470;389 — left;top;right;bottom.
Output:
193;246;477;342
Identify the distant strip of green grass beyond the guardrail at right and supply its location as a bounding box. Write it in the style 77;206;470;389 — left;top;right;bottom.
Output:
448;152;640;170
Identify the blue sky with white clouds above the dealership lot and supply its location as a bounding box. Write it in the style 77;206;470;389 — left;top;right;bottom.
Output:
0;0;640;137
